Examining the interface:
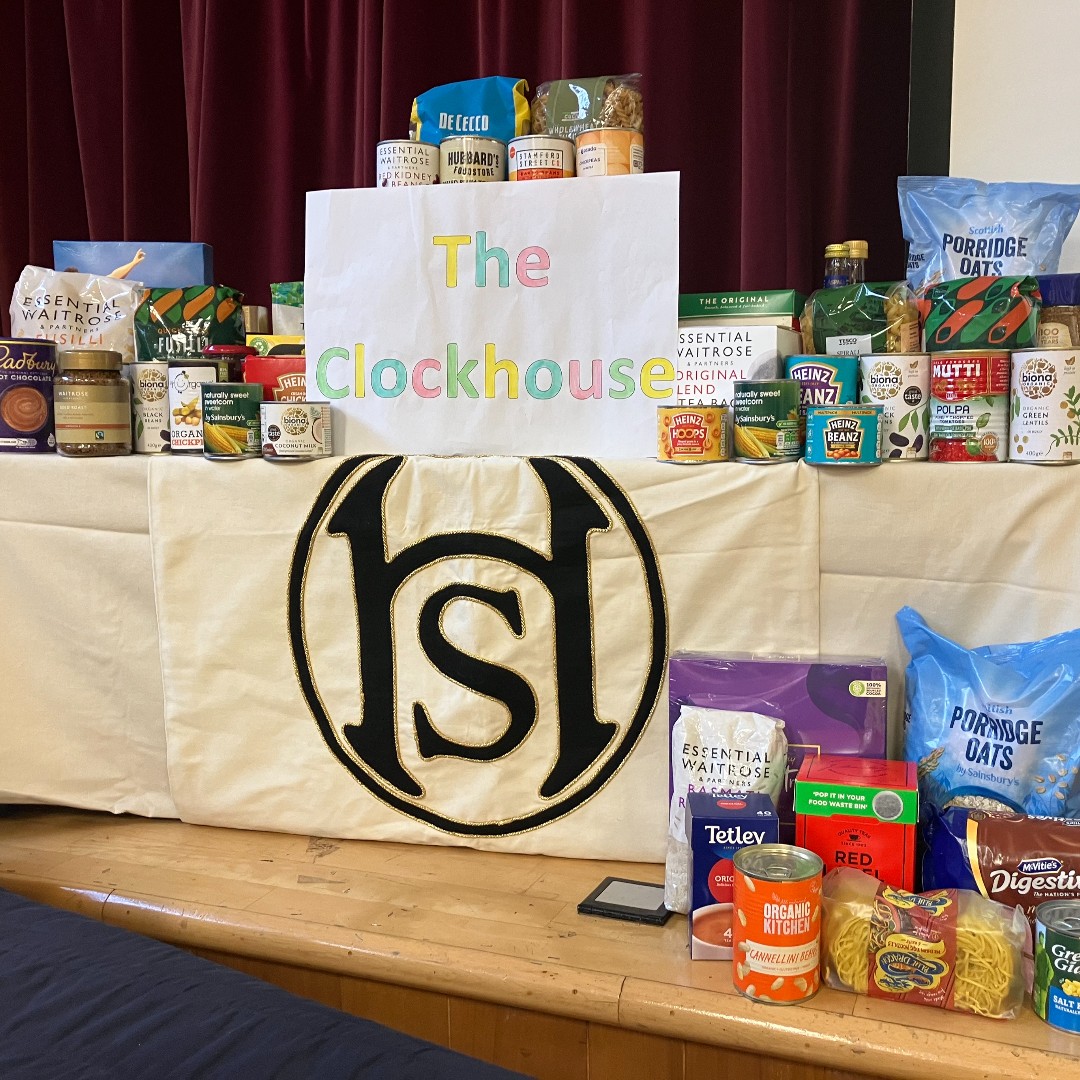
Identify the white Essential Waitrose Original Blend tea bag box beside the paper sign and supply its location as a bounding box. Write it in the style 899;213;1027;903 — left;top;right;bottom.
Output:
675;319;802;405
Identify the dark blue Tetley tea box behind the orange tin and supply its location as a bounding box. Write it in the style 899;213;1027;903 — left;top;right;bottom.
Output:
686;792;780;960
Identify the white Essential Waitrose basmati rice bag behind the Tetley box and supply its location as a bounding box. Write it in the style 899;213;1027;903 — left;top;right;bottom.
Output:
664;705;787;914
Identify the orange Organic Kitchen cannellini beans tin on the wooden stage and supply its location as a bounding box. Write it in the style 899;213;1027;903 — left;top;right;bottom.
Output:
731;843;824;1004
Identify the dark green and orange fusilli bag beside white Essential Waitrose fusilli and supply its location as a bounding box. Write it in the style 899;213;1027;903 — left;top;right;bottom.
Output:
135;285;244;360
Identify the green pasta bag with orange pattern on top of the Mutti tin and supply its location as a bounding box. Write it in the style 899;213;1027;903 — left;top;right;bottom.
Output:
924;278;1041;352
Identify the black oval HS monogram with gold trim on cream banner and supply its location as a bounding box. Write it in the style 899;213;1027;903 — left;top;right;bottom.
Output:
288;456;667;836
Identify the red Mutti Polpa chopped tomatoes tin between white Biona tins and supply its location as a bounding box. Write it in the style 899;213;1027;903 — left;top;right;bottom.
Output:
930;350;1009;461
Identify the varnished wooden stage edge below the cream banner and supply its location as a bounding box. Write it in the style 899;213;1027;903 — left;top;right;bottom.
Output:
0;807;1080;1080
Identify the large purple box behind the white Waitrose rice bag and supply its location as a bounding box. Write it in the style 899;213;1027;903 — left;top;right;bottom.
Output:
667;652;888;843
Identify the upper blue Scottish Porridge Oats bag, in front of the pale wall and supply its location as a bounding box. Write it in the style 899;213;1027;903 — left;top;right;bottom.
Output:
896;176;1080;292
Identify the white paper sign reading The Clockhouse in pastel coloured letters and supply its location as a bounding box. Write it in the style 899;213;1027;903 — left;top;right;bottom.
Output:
305;173;678;458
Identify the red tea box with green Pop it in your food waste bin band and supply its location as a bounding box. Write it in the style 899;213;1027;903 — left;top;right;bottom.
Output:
795;754;919;892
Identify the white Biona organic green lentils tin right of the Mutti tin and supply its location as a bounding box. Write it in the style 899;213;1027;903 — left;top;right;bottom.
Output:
1009;349;1080;465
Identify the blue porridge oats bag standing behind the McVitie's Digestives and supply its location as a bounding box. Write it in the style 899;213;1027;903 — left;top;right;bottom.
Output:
896;607;1080;818
